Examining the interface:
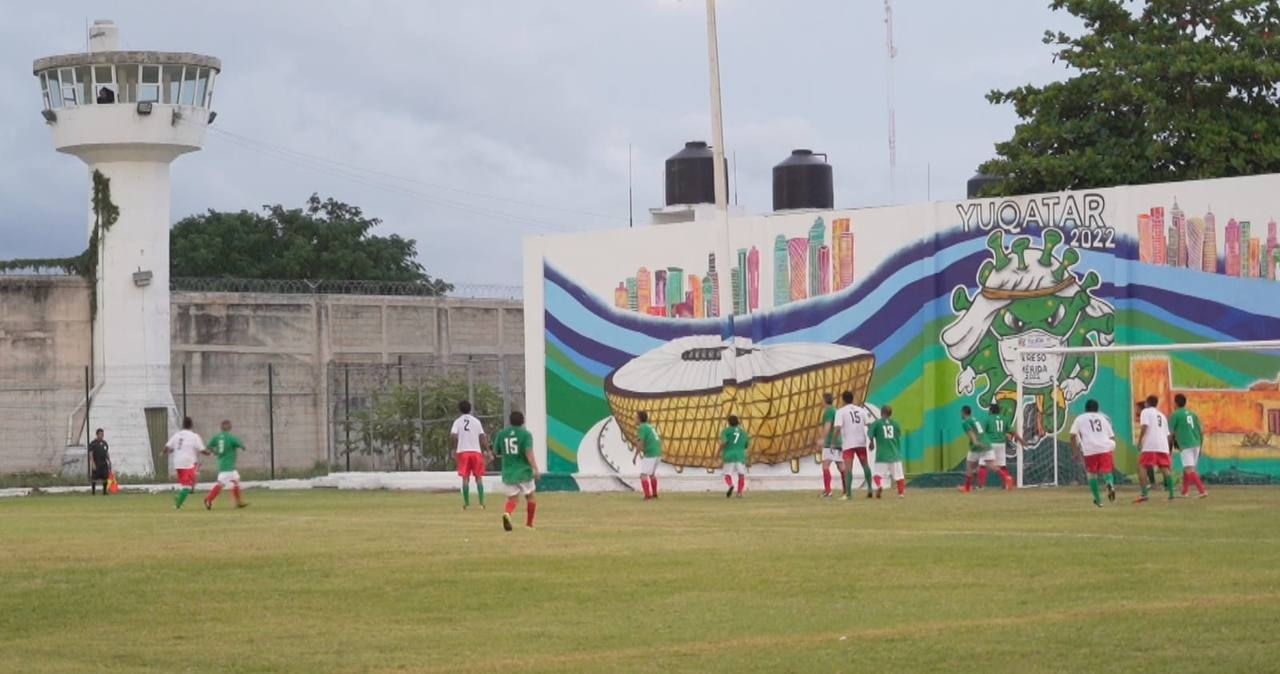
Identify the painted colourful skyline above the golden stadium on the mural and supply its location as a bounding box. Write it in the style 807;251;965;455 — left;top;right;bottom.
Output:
613;217;854;318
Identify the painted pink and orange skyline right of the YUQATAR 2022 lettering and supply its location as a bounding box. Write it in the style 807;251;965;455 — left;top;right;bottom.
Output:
1138;200;1280;280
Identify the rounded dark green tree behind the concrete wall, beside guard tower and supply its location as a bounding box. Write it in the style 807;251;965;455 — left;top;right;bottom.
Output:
169;194;453;293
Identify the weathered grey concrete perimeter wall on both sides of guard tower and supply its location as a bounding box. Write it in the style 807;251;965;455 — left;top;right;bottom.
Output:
0;276;524;473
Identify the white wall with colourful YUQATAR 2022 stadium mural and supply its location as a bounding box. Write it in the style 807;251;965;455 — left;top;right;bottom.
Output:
525;175;1280;481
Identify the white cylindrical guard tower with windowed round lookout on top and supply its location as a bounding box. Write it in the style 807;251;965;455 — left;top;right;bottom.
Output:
32;20;221;477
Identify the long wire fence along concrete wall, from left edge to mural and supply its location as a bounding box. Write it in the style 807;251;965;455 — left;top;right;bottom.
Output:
0;352;525;486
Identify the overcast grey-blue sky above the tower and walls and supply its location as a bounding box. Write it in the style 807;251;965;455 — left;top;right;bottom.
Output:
0;0;1070;285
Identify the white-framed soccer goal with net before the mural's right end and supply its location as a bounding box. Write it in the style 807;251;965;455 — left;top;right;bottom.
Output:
1009;340;1280;486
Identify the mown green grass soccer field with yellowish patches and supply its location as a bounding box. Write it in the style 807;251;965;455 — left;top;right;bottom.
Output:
0;487;1280;674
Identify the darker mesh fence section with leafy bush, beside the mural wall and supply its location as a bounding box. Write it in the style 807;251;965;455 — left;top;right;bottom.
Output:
328;356;525;471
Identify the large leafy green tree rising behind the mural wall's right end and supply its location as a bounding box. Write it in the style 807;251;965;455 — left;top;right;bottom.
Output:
978;0;1280;196
